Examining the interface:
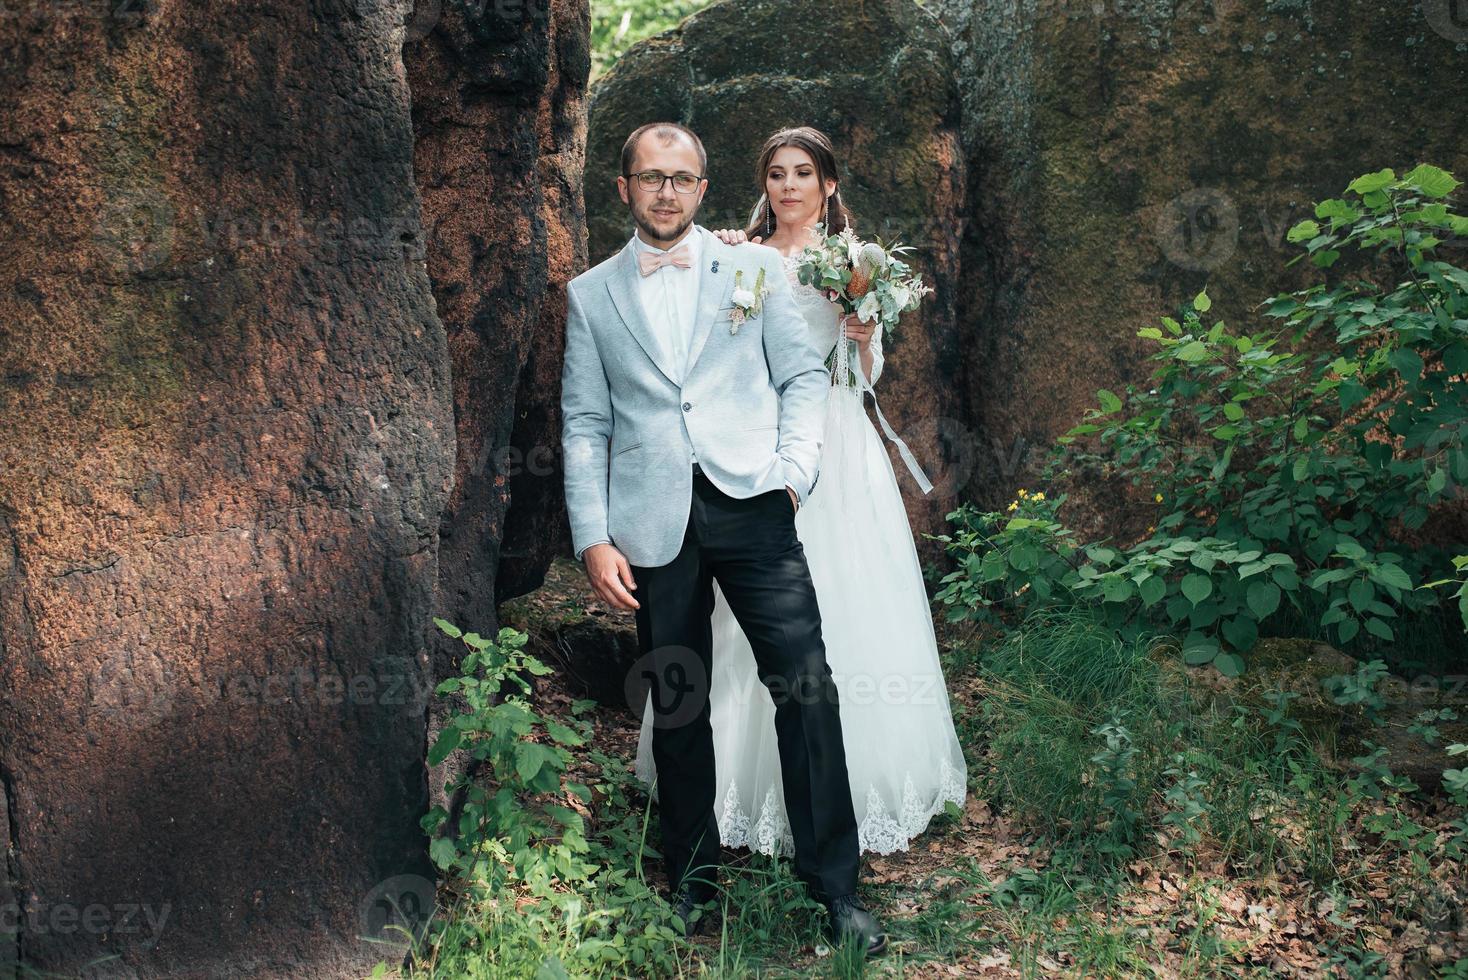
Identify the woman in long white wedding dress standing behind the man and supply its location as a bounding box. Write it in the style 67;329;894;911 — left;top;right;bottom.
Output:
636;126;967;854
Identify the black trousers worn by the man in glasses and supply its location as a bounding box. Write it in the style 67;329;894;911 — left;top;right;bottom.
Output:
633;468;860;901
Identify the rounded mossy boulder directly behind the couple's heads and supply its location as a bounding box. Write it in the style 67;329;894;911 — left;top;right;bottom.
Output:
586;0;969;553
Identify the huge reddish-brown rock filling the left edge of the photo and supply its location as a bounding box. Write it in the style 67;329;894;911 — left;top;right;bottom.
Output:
0;0;455;977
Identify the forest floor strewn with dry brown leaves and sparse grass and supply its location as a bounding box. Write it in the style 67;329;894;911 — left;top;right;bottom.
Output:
466;562;1468;977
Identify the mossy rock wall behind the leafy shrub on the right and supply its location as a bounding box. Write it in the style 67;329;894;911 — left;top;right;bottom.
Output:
929;0;1468;534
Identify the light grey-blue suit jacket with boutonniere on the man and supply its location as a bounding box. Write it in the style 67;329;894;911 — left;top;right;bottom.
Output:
561;224;831;568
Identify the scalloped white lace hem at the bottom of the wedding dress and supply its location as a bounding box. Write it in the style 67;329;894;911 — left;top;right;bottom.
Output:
719;758;967;855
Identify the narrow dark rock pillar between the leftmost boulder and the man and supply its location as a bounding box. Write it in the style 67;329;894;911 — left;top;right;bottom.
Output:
404;0;590;821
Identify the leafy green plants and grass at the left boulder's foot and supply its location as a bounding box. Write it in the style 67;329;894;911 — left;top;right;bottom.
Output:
415;619;681;977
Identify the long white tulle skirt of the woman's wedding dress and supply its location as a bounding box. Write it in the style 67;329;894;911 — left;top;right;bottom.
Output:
636;387;967;854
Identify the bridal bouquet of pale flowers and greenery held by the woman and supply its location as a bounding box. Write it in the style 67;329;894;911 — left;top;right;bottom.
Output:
796;224;932;384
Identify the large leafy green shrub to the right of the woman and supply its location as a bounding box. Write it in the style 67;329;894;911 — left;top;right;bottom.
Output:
937;166;1468;675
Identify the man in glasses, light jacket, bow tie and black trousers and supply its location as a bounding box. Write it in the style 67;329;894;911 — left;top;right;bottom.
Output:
561;123;887;954
